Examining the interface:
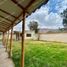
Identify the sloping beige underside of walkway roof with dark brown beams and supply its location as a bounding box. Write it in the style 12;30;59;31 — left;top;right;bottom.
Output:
0;0;48;32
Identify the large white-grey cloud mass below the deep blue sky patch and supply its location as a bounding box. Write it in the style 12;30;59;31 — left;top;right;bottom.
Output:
27;6;63;28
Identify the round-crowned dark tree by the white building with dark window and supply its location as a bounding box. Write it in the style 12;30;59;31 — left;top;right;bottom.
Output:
28;21;39;40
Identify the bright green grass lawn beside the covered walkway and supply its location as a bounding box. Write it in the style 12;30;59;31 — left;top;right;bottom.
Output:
12;41;67;67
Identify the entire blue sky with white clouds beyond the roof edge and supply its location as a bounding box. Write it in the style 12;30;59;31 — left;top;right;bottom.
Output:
14;0;67;31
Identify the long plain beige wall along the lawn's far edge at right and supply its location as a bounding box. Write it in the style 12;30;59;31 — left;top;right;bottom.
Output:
40;33;67;43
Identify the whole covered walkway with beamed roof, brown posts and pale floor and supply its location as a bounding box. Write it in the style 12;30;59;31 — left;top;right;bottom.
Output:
0;0;48;67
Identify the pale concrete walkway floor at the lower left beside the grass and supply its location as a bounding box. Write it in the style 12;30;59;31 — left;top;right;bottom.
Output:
0;45;14;67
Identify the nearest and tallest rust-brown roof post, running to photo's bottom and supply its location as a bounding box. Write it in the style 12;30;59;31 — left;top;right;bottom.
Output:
21;10;25;67
